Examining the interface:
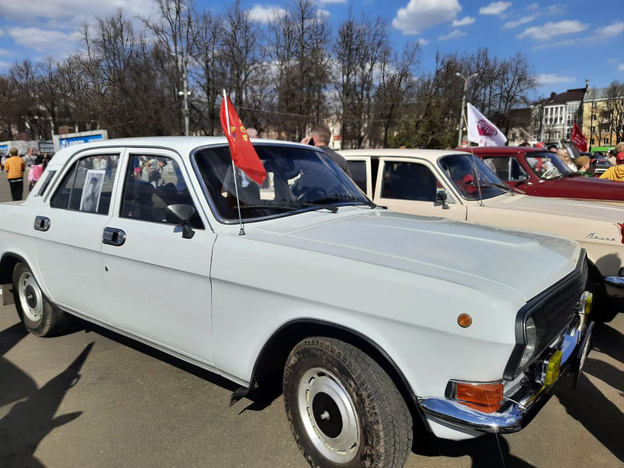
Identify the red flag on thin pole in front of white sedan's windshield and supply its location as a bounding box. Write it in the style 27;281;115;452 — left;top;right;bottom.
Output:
221;96;266;184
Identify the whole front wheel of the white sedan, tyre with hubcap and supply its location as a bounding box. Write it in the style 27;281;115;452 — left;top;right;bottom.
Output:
284;337;413;468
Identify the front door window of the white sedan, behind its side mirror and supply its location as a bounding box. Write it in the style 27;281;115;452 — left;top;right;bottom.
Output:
119;154;203;229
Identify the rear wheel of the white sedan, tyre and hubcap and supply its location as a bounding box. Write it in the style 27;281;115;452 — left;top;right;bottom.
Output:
13;263;69;336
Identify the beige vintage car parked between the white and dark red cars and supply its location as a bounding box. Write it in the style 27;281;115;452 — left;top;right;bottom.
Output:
340;149;624;321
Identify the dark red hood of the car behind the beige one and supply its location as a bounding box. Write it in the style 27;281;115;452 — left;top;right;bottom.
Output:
516;176;624;201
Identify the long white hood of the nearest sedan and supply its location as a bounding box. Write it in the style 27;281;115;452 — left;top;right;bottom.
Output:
247;208;581;300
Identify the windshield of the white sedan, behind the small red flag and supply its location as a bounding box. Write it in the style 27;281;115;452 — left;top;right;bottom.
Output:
194;145;373;222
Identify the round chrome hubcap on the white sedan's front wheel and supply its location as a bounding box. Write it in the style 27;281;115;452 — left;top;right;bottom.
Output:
297;367;360;463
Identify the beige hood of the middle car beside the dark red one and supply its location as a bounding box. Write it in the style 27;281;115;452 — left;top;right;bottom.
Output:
483;195;624;223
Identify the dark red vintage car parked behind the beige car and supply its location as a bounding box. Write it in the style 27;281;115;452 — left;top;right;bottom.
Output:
458;146;624;201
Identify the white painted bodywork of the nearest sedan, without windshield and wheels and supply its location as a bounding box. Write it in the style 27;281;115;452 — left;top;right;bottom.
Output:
0;138;592;450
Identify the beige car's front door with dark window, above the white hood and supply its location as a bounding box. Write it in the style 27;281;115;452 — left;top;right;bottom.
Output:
373;158;466;221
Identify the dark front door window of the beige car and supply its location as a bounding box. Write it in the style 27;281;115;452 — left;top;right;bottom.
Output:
381;162;436;202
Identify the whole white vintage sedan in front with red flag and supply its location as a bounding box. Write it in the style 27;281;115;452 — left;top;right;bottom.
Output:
0;137;593;466
